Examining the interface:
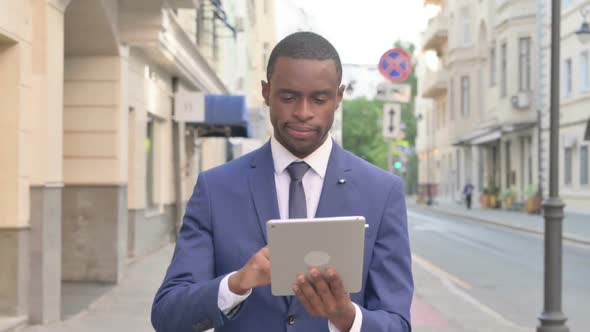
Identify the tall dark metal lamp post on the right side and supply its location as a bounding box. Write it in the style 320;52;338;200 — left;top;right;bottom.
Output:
537;0;569;332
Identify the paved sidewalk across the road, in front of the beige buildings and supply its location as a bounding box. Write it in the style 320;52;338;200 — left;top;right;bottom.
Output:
408;198;590;245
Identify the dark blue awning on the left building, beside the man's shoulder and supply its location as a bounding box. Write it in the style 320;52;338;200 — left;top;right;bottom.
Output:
205;95;251;137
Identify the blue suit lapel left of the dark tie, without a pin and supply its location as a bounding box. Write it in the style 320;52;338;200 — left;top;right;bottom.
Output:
249;142;280;244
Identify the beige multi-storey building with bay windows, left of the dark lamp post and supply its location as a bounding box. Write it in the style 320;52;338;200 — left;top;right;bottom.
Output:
418;0;538;206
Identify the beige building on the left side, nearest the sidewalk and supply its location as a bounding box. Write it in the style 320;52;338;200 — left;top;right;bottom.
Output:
0;0;274;331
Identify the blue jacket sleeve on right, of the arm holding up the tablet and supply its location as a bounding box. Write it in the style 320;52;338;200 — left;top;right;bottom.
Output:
361;177;414;332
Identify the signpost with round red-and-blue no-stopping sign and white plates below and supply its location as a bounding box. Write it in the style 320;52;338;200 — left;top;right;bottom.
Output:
376;48;412;172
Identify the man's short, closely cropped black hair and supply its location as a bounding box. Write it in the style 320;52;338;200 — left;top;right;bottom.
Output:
266;31;342;83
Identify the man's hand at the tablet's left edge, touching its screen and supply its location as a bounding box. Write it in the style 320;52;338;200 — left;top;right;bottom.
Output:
228;247;270;295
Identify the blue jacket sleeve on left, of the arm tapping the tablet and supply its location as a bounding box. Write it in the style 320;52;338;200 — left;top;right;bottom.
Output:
151;173;232;332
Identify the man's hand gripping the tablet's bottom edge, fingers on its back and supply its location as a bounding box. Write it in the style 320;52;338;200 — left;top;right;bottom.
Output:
293;267;356;332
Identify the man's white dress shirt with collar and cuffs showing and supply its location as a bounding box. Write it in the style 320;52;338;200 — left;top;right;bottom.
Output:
217;136;363;332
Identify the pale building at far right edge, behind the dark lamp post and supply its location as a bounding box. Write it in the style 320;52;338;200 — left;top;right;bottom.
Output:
539;0;590;212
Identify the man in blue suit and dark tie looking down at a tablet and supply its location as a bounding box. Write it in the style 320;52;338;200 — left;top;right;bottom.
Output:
152;32;413;332
